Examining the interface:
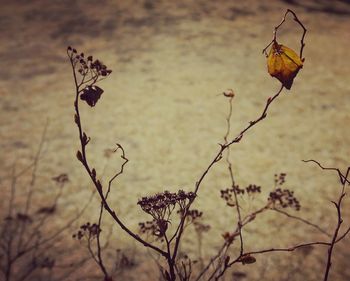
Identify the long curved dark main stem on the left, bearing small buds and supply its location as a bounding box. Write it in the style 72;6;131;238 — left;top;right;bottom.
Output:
67;50;167;257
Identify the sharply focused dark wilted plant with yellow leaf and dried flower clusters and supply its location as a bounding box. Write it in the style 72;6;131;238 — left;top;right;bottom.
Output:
67;10;350;281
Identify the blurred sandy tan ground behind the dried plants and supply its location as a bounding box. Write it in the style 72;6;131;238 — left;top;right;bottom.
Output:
0;0;350;281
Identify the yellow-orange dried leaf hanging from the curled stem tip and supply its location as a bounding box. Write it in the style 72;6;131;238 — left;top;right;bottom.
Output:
267;42;303;90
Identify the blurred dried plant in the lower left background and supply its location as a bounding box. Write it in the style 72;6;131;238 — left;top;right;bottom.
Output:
0;127;93;281
